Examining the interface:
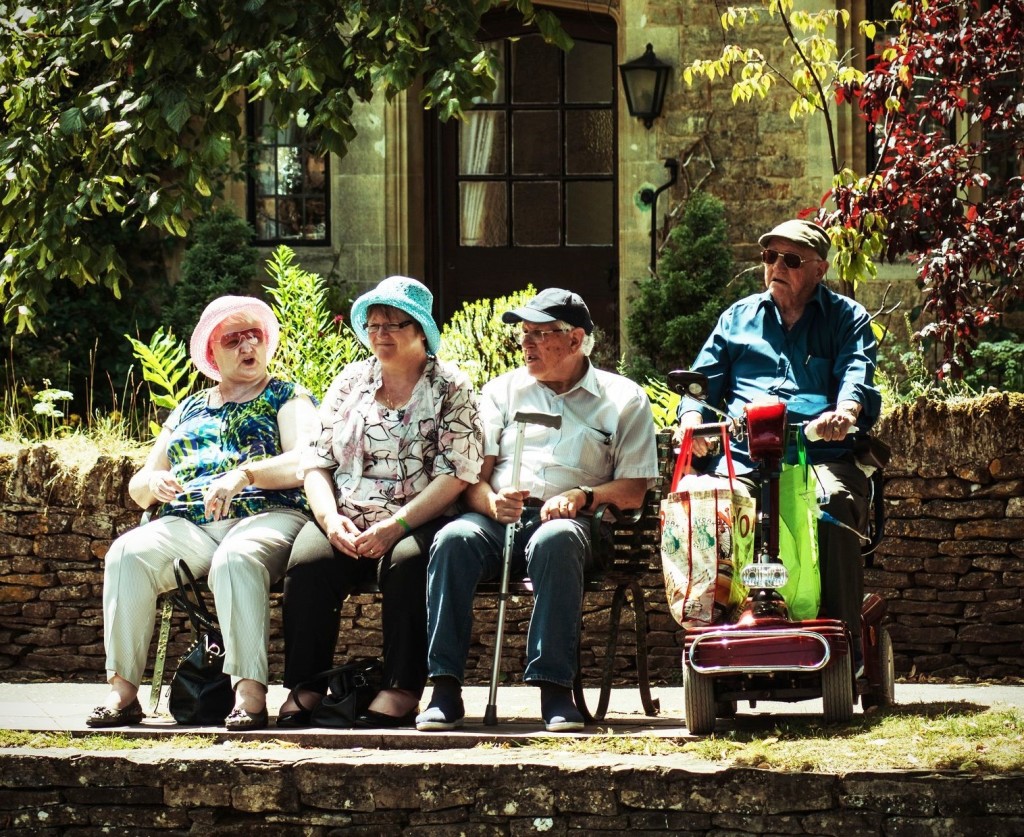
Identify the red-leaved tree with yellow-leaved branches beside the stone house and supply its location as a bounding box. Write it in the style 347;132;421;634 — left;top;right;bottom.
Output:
683;0;1024;376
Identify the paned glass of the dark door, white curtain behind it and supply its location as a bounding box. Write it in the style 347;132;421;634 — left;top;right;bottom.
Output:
458;34;614;248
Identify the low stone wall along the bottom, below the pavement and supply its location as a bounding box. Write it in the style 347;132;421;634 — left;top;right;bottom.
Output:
0;748;1024;837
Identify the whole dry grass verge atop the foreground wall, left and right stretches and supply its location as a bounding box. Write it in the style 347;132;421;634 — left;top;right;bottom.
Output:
8;704;1024;775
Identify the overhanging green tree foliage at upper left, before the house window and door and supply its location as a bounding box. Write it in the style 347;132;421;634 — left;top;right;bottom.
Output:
0;0;569;331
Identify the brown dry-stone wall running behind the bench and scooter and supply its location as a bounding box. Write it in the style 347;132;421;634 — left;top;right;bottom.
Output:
0;395;1024;683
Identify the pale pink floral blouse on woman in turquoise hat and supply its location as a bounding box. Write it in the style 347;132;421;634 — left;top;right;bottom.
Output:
303;358;483;530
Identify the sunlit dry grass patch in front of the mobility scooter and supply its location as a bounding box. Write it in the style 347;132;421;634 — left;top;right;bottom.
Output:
481;705;1024;773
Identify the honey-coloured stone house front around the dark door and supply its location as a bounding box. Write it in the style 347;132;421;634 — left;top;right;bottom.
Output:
216;0;907;348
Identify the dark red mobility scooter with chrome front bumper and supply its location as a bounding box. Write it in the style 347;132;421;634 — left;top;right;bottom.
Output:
669;371;895;735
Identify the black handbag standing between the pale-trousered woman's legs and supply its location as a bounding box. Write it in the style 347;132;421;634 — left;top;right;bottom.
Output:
168;558;234;726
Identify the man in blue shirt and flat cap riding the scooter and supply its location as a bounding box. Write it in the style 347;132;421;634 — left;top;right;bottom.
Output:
680;220;882;670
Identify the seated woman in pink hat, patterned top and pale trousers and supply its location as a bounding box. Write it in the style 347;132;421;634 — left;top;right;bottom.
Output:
86;296;316;730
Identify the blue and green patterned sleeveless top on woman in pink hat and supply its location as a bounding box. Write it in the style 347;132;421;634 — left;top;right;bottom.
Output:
158;378;309;524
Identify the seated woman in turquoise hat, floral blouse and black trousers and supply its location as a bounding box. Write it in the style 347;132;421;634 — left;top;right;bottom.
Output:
278;277;483;727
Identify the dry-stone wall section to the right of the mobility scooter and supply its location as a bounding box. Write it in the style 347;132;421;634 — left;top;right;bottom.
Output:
865;393;1024;678
